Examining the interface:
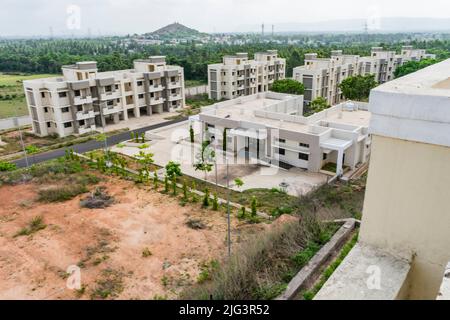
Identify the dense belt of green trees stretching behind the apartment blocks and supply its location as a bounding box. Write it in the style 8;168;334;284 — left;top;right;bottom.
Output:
0;38;450;81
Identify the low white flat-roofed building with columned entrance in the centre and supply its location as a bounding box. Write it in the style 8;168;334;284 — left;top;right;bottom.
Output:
195;91;370;175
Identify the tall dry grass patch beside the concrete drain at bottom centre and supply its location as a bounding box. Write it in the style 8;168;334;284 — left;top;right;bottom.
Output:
181;218;337;300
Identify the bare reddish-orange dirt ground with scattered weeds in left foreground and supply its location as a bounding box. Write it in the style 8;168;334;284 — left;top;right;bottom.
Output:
0;178;284;299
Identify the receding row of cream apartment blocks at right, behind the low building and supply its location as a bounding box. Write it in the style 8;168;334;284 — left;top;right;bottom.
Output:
293;46;435;105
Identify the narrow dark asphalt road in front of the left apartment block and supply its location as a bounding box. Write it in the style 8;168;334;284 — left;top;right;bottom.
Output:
12;118;187;168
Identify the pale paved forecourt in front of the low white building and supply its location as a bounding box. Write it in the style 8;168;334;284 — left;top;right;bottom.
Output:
112;122;327;196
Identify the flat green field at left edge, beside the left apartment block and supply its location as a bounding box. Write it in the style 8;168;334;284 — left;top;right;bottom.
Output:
0;73;57;119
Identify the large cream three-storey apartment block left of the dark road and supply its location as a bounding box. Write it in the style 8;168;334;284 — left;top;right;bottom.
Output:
24;56;185;137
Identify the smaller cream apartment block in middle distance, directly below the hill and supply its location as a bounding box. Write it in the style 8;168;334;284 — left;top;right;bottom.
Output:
208;50;286;100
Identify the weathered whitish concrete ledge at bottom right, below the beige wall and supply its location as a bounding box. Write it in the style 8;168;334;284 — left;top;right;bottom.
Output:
314;243;410;300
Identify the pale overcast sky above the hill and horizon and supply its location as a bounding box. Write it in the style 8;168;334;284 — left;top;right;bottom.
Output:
0;0;450;36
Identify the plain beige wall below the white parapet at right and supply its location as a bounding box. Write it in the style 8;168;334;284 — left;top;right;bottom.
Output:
360;135;450;299
